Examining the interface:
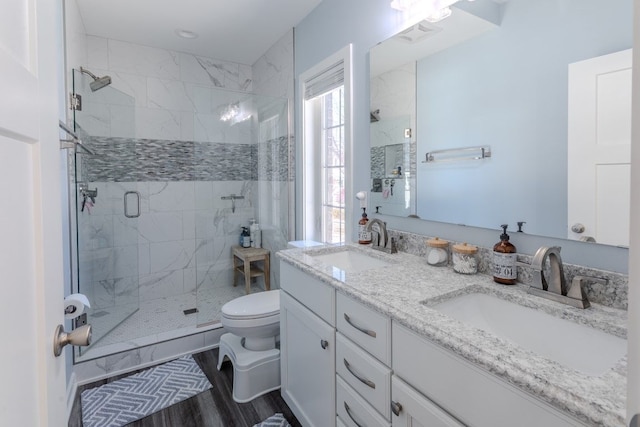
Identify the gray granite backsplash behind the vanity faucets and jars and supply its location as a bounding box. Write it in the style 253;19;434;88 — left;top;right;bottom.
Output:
389;230;629;310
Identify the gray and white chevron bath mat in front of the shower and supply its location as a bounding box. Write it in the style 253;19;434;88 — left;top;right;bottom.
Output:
80;356;211;427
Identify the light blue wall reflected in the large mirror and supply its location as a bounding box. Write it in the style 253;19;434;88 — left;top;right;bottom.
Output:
417;0;633;236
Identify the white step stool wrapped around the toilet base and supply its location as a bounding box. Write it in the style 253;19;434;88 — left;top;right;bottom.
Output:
218;333;280;403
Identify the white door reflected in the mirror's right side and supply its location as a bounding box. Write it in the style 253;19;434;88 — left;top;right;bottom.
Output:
568;49;631;246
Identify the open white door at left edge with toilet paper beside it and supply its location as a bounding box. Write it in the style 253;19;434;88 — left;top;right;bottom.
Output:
0;0;67;426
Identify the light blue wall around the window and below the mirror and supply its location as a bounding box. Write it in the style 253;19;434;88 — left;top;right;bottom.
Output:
294;0;628;273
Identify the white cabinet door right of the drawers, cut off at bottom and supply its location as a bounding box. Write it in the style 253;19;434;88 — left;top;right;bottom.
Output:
391;375;463;427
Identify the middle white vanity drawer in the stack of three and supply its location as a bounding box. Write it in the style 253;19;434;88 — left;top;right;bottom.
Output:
336;333;391;420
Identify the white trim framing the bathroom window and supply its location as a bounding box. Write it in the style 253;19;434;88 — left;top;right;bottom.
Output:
297;44;354;242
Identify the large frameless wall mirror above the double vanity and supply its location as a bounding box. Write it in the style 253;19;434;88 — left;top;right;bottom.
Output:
369;0;633;246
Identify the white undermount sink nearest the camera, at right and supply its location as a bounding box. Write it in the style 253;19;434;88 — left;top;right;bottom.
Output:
431;293;627;376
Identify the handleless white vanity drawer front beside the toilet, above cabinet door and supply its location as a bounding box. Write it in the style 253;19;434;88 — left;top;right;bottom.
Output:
280;261;336;326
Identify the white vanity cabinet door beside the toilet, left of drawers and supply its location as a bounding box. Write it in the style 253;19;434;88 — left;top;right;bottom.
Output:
280;292;336;427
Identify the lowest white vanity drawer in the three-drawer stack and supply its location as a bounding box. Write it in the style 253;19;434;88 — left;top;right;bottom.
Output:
336;377;391;427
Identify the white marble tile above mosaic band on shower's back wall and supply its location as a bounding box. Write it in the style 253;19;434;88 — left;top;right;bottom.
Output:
80;36;253;142
